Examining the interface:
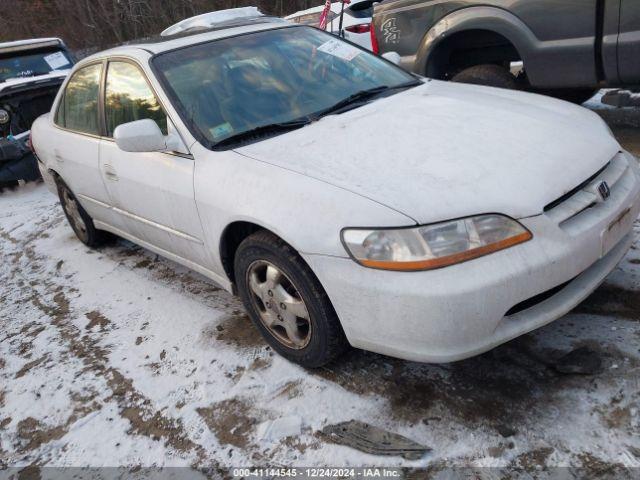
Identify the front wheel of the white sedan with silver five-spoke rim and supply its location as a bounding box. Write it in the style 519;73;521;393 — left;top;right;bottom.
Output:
234;231;348;368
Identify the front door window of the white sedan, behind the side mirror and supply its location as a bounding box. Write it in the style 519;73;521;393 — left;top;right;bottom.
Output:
104;61;167;137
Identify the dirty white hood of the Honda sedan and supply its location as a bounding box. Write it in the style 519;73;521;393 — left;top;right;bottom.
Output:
236;81;620;224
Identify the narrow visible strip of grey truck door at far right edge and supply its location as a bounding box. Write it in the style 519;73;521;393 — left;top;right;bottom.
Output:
618;0;640;84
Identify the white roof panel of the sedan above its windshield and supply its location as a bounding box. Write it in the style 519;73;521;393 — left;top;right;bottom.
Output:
81;16;296;63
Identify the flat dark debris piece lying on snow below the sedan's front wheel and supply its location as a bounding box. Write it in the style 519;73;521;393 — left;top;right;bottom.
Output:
322;420;431;460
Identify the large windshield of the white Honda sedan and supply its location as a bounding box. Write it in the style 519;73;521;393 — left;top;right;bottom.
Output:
153;27;416;148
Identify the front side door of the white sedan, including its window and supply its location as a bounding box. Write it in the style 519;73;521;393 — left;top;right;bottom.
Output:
100;59;208;267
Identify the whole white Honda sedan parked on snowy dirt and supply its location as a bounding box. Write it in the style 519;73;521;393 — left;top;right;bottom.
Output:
32;11;640;367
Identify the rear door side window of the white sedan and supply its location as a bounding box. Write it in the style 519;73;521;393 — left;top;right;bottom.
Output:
56;63;102;135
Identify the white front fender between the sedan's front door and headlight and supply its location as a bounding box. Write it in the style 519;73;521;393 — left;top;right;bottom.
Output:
193;144;416;282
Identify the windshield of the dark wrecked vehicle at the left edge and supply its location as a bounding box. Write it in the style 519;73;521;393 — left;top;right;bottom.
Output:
0;48;72;82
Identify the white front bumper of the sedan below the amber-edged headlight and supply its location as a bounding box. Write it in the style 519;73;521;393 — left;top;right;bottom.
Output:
304;154;640;363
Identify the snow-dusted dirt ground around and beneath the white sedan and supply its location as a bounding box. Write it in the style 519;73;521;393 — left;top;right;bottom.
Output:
0;101;640;476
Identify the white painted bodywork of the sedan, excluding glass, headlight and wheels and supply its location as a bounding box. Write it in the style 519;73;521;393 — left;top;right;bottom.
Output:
33;27;640;362
